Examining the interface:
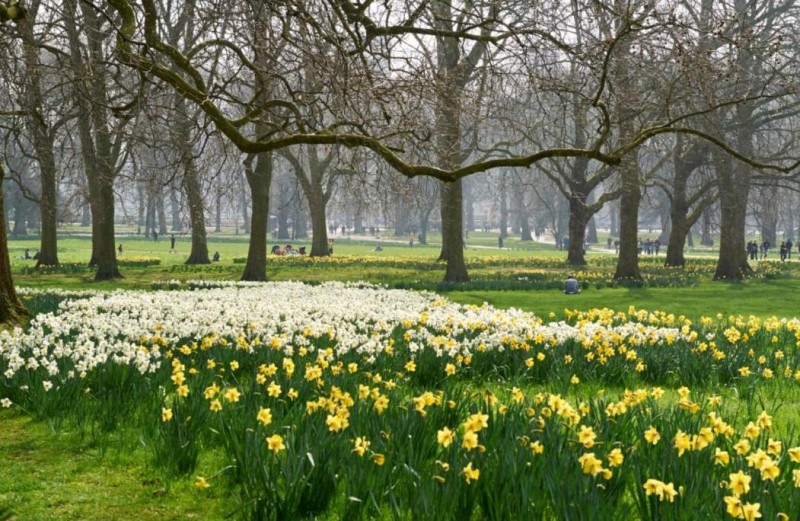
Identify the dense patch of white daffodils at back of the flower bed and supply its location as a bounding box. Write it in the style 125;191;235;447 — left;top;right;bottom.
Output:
0;281;694;389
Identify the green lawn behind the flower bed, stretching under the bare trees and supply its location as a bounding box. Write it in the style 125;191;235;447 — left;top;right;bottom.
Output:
9;232;800;317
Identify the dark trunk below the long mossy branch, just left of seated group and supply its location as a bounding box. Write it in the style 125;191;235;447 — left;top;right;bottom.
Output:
242;153;272;281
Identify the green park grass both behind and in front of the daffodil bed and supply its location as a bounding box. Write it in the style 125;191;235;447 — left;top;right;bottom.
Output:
0;234;800;520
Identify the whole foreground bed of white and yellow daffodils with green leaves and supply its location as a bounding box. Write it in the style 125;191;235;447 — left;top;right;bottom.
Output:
0;283;800;519
